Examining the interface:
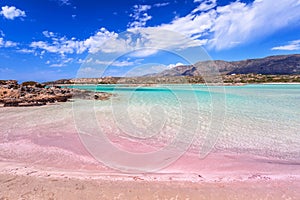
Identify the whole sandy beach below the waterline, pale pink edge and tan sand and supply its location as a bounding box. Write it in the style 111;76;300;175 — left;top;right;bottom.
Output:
0;153;300;199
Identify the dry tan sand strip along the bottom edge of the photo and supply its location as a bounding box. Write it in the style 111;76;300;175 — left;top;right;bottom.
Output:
0;171;300;200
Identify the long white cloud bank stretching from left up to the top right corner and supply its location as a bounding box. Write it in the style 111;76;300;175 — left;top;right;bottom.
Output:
28;0;300;59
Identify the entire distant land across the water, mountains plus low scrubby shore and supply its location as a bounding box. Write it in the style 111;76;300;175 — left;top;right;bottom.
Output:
45;54;300;85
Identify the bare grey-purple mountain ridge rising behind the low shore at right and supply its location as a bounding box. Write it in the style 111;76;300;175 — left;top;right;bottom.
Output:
146;54;300;77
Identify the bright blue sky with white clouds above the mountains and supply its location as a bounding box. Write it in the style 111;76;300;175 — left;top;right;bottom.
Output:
0;0;300;82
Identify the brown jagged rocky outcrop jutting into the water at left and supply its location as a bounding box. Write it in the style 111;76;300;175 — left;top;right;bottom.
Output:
0;80;111;107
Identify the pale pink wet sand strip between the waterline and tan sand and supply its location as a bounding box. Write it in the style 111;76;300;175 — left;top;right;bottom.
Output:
0;157;300;186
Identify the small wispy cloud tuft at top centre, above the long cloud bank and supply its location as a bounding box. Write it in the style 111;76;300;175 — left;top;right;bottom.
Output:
128;5;152;28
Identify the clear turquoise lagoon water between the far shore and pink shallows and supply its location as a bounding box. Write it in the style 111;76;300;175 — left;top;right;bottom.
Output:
71;84;300;160
